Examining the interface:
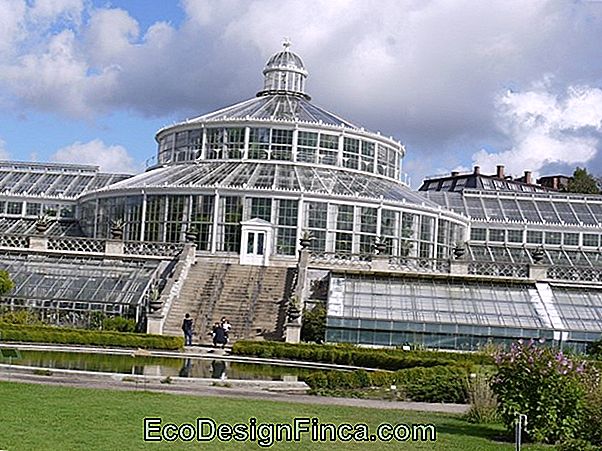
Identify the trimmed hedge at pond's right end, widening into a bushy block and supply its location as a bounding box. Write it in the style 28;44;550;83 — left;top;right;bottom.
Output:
304;366;468;404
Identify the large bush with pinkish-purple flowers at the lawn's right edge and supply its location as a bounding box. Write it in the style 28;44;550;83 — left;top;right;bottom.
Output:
492;340;584;443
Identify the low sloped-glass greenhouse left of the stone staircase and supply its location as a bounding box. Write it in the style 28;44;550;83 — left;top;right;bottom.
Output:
0;253;160;326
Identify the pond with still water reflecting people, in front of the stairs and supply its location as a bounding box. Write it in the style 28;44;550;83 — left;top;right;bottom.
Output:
1;350;315;380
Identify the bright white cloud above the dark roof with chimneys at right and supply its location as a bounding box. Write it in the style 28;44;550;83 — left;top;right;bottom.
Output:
473;83;602;174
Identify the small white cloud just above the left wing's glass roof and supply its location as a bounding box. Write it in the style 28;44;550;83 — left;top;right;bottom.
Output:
51;139;137;173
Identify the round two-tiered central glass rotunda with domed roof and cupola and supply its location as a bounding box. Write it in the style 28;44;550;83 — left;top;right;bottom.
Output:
80;46;468;261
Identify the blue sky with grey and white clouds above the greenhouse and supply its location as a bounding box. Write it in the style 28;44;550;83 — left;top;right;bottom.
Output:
0;0;602;187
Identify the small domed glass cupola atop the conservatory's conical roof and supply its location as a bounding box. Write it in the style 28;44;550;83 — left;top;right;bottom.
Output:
257;39;311;100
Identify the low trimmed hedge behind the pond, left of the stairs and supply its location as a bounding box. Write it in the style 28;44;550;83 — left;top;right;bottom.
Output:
0;323;184;350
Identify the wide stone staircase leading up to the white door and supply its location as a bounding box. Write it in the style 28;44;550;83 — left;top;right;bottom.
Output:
163;258;294;343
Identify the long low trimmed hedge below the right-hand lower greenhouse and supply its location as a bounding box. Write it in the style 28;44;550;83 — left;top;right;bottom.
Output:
232;341;493;371
